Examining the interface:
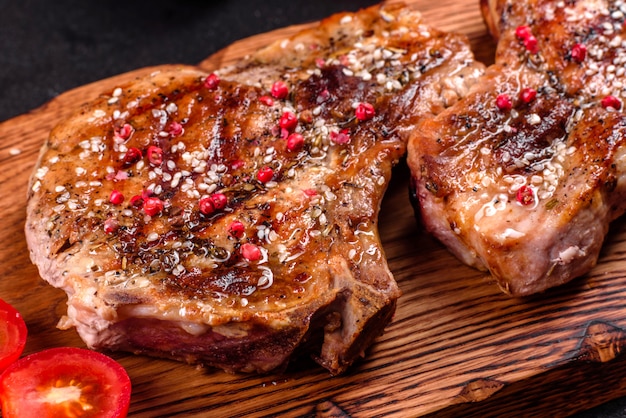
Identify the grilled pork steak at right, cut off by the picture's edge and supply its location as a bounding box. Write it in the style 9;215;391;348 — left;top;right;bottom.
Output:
408;0;626;295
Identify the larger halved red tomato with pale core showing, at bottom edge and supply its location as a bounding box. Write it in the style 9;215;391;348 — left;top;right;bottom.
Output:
0;347;131;418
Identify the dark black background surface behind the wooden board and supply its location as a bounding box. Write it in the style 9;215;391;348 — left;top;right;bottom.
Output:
0;0;626;418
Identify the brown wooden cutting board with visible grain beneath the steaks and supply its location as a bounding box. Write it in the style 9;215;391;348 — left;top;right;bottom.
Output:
0;0;626;417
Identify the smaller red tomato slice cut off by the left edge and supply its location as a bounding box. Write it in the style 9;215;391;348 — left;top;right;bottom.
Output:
0;299;28;372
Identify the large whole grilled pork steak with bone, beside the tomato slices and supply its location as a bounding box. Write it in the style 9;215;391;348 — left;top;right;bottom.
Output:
26;5;482;373
